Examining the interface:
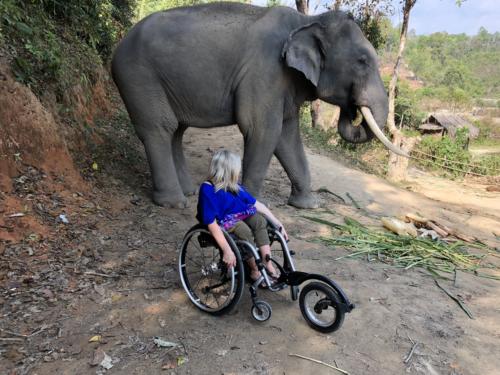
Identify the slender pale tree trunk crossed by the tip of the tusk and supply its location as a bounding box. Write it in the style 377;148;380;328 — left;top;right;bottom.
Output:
387;0;417;181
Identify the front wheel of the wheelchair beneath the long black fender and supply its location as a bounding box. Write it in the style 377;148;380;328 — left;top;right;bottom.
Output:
299;282;344;333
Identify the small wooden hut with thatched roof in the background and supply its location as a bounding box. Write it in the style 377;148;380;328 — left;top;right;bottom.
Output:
418;112;479;139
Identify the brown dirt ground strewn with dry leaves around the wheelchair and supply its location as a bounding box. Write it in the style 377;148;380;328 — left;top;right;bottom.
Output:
0;113;500;375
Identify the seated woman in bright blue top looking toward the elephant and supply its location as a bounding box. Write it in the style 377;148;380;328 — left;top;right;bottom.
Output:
196;150;288;280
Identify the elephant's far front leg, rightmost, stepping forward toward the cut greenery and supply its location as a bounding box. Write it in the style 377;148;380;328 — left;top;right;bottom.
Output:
274;114;318;208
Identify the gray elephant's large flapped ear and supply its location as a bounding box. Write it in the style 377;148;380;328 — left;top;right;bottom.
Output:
281;22;325;86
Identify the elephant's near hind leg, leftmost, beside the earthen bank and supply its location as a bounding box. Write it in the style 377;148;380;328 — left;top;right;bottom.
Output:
118;72;187;208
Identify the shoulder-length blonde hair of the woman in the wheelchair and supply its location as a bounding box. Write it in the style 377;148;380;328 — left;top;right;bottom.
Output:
208;150;241;193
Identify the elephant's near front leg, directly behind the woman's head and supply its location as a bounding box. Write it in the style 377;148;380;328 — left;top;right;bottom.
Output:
239;112;283;197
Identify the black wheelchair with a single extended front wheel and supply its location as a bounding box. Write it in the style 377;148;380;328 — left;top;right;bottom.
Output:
179;220;354;333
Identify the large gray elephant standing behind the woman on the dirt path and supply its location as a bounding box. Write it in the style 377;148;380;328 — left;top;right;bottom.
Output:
112;3;388;208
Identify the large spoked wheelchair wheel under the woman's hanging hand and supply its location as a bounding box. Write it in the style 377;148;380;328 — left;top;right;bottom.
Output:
179;225;245;315
